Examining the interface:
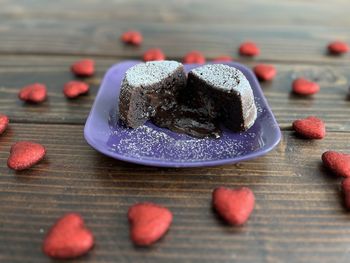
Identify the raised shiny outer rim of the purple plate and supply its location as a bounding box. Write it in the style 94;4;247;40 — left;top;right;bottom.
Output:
84;60;282;168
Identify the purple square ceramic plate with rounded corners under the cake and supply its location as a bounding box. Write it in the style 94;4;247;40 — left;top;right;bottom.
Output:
84;61;281;167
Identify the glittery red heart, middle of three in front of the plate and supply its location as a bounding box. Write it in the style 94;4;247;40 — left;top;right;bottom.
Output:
128;203;173;246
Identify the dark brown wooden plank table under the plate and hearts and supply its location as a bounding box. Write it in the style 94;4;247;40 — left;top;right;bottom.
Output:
0;0;350;263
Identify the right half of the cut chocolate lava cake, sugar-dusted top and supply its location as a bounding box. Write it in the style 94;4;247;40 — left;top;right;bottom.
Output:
184;64;257;132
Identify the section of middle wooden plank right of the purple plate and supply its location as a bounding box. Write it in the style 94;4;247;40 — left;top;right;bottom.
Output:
262;64;350;131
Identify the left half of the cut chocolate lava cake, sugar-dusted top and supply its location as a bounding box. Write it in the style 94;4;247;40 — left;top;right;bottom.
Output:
119;61;186;128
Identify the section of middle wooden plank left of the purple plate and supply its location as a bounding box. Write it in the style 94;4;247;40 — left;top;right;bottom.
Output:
0;56;116;124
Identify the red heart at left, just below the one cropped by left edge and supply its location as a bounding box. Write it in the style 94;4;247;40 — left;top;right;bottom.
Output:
7;141;46;171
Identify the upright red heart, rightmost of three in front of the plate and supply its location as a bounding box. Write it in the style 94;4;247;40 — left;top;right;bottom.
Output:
212;187;255;225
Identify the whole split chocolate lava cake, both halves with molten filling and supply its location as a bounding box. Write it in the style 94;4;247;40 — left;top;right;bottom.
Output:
119;61;257;138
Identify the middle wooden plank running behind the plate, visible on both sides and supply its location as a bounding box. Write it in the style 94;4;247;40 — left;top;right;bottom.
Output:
0;56;350;131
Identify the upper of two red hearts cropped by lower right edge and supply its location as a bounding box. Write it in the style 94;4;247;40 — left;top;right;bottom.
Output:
322;151;350;177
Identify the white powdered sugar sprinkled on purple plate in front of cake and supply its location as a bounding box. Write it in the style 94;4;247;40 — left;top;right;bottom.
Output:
110;125;255;162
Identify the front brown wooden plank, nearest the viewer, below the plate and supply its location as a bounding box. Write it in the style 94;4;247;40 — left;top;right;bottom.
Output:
0;124;350;262
